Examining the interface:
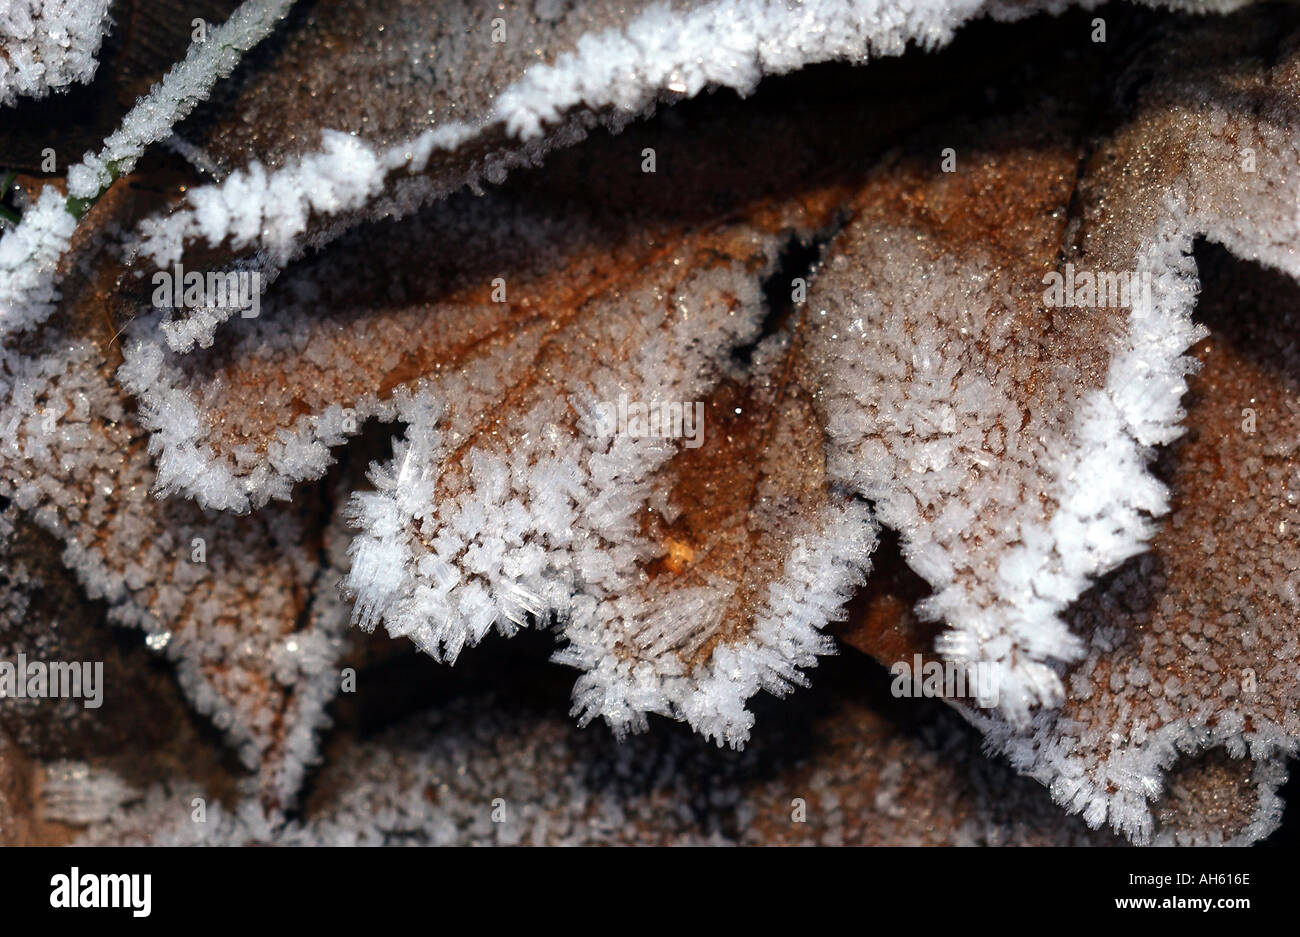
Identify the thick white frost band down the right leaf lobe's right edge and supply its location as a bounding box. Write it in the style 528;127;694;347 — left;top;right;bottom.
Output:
924;217;1205;724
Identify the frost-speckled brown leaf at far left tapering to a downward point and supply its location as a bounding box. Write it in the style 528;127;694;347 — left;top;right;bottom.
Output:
0;179;356;801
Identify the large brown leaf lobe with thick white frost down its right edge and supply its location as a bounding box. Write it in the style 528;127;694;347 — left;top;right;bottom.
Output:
810;10;1297;724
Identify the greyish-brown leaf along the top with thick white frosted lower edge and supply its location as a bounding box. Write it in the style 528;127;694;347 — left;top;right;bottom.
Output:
122;0;1242;350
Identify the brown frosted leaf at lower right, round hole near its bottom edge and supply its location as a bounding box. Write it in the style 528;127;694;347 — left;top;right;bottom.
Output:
991;239;1300;842
